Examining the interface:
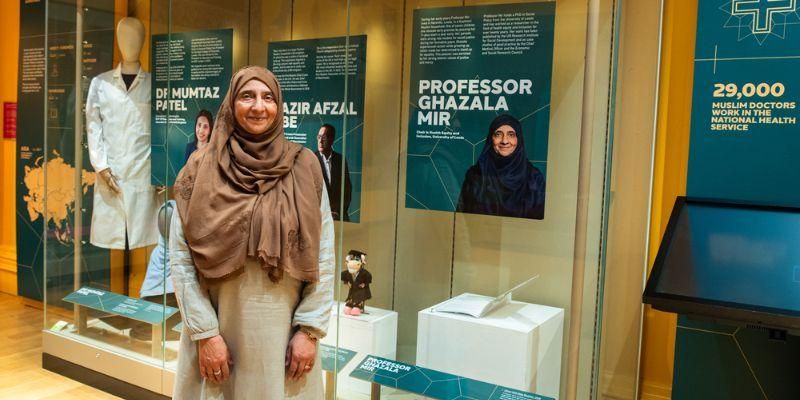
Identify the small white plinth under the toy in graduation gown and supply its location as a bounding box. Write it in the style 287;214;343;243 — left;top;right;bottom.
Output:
322;303;397;396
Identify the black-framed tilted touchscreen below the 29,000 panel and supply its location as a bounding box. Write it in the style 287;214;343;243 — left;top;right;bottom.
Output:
643;197;800;334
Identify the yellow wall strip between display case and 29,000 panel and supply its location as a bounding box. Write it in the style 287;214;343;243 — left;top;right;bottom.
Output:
640;0;697;399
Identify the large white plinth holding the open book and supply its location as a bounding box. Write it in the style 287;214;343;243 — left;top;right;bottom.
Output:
417;297;564;398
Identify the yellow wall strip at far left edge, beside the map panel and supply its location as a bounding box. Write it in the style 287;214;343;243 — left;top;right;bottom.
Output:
0;1;19;294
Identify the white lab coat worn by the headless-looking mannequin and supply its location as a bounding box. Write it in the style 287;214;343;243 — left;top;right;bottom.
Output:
86;64;161;249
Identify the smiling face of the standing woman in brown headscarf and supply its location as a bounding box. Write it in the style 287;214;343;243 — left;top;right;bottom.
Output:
234;79;278;135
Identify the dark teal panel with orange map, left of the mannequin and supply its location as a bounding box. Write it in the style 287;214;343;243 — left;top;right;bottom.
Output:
16;0;114;307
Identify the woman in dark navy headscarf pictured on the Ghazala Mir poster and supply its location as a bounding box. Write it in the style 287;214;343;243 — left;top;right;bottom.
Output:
456;115;544;219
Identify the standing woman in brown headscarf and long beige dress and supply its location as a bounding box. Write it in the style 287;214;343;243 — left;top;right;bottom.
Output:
170;67;334;399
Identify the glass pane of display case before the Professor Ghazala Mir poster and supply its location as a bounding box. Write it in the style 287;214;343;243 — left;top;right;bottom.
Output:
326;1;613;398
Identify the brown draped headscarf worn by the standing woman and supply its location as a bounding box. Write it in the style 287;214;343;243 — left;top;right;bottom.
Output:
175;67;323;282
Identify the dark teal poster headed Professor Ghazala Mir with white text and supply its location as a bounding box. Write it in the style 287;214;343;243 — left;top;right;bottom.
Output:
401;2;555;219
